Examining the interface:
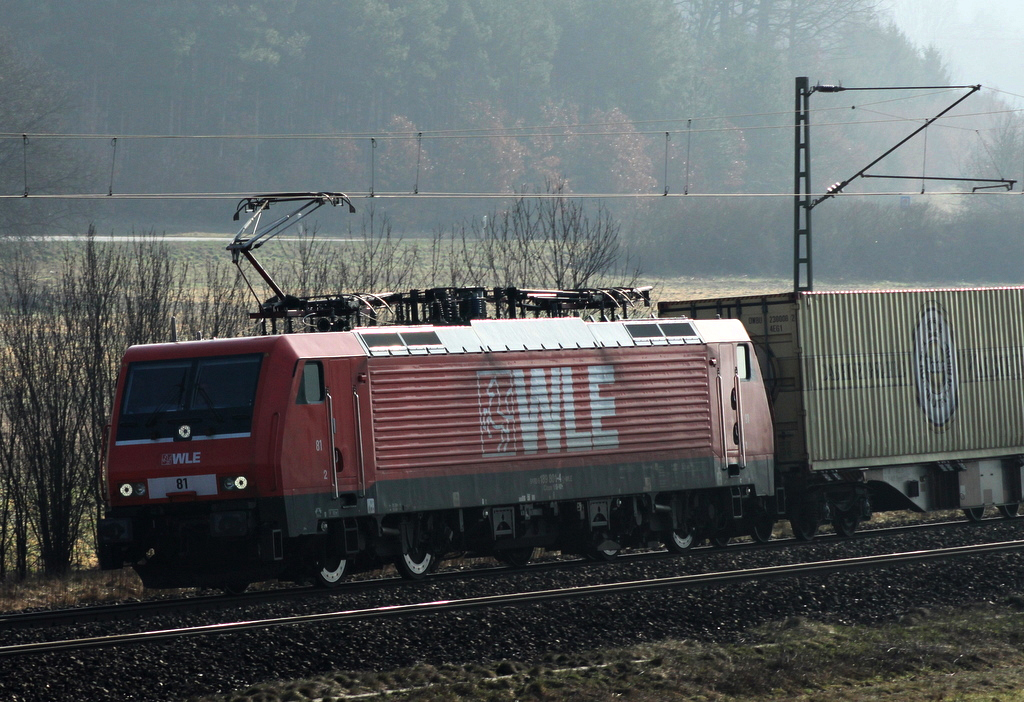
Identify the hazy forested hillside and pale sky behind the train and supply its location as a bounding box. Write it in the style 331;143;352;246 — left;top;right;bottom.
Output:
0;0;1024;284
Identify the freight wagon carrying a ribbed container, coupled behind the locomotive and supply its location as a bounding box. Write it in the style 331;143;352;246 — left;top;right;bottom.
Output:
658;288;1024;538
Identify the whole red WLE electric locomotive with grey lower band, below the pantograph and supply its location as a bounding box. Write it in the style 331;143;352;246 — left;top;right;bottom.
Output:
99;318;782;589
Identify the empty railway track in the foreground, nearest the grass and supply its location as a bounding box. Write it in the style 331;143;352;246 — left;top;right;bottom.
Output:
0;540;1024;658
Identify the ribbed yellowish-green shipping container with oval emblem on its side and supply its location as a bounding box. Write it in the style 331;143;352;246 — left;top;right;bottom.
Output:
658;288;1024;471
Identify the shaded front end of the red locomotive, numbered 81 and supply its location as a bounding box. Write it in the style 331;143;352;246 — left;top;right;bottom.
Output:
98;344;280;586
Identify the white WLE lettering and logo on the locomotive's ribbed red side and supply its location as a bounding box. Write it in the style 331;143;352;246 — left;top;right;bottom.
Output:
476;365;618;456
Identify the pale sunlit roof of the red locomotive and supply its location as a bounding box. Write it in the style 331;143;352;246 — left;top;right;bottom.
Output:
126;317;749;360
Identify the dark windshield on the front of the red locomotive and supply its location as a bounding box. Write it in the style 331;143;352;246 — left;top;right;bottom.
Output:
117;354;262;441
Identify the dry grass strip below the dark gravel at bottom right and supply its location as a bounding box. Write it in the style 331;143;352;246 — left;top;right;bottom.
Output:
193;600;1024;702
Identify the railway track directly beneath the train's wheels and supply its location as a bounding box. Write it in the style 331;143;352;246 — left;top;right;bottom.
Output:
0;511;1024;629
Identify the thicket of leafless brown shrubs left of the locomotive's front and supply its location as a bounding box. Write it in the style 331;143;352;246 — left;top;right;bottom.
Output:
0;227;220;577
